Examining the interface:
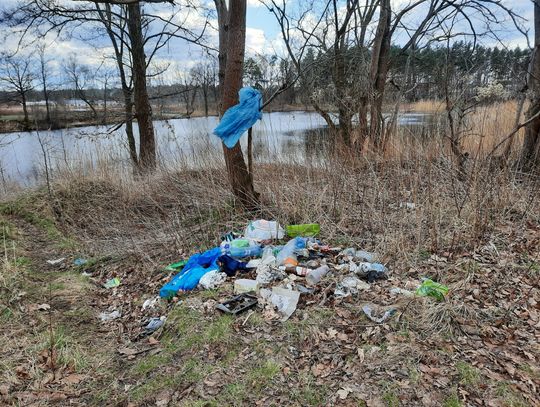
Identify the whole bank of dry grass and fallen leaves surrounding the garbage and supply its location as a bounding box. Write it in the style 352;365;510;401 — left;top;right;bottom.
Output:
0;152;540;406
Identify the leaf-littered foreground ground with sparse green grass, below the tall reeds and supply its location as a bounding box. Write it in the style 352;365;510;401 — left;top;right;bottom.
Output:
0;188;540;407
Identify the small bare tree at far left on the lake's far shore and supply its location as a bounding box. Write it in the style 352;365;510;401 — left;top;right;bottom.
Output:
0;56;35;130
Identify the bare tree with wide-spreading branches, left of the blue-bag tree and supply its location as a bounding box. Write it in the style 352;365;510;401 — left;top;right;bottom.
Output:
0;0;212;171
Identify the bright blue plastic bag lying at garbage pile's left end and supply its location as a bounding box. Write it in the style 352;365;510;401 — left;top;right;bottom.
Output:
159;247;221;298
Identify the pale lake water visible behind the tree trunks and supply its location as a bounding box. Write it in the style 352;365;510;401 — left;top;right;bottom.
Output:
0;112;431;184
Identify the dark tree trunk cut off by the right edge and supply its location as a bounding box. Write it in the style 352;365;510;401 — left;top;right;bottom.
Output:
520;0;540;171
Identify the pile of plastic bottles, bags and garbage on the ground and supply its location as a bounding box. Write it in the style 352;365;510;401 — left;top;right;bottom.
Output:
156;220;438;321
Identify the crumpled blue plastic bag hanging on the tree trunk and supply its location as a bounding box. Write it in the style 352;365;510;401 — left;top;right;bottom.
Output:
214;86;262;148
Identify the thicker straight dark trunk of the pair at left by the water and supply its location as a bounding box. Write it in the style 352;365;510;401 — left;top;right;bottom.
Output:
128;3;156;171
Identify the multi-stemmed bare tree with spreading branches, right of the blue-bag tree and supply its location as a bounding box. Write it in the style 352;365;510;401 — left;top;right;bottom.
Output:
263;0;520;150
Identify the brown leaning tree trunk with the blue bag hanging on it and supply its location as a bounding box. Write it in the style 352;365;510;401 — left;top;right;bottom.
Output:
216;0;259;209
